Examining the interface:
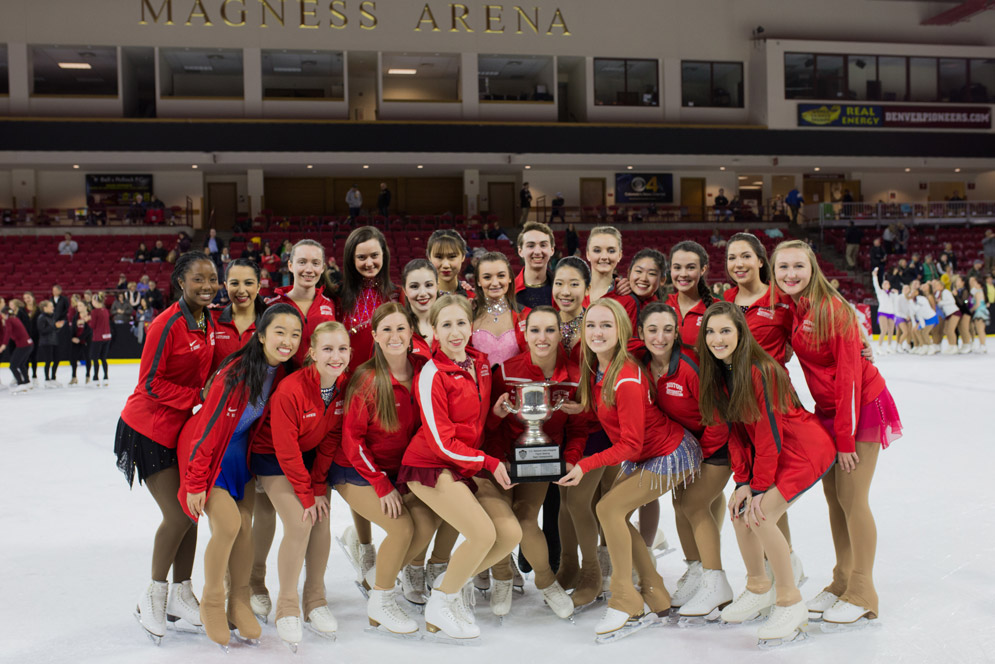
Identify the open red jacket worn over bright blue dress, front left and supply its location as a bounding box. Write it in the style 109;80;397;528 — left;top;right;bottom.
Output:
176;365;286;521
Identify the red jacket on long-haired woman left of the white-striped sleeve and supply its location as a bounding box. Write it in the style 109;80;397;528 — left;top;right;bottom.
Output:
335;354;427;498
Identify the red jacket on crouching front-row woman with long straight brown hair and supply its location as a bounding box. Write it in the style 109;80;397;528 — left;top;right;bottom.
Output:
729;367;836;502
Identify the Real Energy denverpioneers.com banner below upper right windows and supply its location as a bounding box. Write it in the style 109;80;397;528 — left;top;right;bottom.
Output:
798;104;992;129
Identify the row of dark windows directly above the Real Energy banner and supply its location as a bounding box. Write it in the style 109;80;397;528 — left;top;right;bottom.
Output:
784;53;995;104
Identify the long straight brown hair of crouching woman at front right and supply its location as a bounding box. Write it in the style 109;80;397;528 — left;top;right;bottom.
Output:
695;301;800;426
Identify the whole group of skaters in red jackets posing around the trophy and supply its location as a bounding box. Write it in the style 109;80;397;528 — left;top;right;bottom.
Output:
115;222;901;650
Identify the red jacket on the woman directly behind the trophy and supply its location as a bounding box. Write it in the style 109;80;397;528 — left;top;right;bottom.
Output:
483;348;588;464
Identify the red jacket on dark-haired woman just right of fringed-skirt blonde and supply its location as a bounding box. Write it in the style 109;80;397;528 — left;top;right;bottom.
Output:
629;341;729;459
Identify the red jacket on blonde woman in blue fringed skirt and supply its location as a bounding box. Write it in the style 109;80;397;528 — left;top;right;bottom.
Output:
580;359;684;473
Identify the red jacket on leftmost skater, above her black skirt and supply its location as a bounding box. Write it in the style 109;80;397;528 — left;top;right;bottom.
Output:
121;299;214;446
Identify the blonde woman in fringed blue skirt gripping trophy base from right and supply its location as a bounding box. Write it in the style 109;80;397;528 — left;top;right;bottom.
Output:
558;298;701;643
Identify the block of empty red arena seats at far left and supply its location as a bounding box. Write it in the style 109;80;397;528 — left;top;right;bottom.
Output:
0;233;176;298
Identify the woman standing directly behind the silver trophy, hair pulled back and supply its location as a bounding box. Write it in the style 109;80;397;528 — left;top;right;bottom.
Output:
486;305;587;618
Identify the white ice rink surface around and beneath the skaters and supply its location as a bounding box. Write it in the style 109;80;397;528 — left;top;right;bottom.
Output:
0;354;995;664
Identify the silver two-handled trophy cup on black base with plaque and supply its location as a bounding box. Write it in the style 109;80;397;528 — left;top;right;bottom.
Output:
504;382;566;482
